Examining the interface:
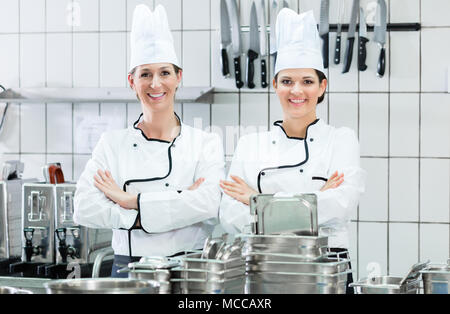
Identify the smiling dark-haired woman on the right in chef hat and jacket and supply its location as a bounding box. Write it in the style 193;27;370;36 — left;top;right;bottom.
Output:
220;9;364;294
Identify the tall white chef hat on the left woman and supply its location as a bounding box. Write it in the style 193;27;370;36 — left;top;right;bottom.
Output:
129;4;180;72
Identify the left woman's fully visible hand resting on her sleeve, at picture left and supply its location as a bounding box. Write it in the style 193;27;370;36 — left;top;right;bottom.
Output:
94;170;138;209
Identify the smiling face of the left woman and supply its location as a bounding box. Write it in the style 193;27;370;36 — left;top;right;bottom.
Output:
128;63;182;112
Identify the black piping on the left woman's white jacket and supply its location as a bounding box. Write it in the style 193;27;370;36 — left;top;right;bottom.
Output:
122;112;182;257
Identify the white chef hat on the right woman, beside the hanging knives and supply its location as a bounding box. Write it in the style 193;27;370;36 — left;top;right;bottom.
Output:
275;8;325;74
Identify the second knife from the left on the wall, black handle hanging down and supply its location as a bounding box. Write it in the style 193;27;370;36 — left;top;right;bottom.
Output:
229;0;244;88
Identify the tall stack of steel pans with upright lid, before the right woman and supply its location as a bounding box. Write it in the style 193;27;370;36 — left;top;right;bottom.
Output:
241;194;350;294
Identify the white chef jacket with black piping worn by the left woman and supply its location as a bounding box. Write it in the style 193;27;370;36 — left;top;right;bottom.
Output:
74;115;225;256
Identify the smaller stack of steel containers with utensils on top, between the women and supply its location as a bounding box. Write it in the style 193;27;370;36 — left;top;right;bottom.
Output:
171;235;245;294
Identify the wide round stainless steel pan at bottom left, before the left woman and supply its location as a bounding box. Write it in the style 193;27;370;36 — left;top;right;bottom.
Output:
44;278;159;294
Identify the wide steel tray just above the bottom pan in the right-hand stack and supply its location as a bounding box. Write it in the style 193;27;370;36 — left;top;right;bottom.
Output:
246;258;350;274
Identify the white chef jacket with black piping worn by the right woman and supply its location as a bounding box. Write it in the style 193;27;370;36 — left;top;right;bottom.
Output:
219;119;365;248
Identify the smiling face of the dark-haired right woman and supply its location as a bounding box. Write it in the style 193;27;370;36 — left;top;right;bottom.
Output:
273;69;327;122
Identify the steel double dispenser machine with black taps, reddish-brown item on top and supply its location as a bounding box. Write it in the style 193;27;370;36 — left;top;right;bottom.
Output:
10;164;112;279
